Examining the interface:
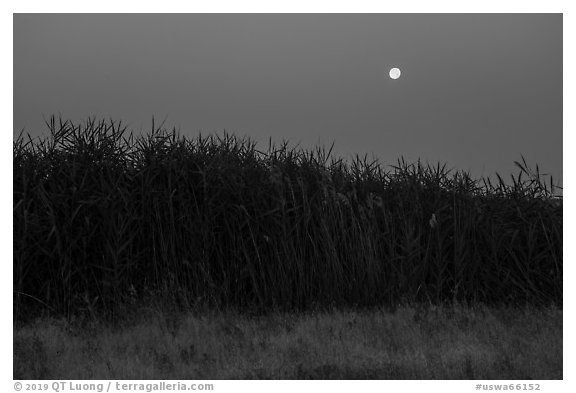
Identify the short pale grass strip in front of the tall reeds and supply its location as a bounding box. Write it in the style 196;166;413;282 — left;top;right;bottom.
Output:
14;306;563;379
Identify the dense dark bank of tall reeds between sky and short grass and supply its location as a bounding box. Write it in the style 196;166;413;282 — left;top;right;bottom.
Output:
13;117;562;318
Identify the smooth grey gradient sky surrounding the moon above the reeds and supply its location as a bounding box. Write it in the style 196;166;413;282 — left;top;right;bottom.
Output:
13;14;562;188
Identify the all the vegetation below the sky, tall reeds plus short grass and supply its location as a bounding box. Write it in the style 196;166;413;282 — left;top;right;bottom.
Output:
13;117;563;379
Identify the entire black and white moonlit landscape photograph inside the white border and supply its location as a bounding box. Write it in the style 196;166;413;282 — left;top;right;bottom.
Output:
9;10;565;382
